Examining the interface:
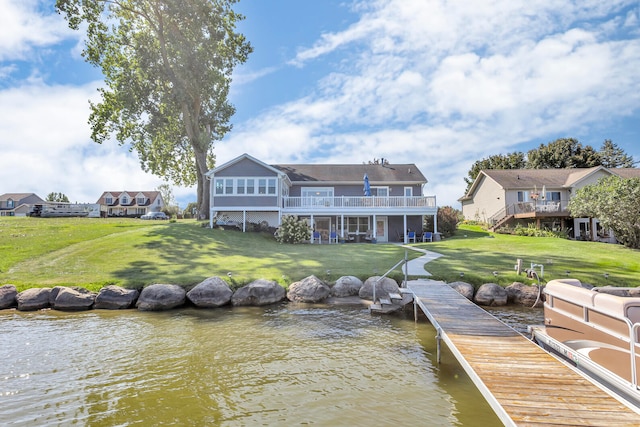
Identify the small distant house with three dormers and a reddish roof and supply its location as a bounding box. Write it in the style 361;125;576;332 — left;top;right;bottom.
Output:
96;191;164;217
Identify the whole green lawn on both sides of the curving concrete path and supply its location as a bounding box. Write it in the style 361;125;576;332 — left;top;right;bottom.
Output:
0;217;640;290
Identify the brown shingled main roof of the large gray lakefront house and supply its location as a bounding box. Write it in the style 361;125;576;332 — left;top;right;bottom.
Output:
273;163;427;185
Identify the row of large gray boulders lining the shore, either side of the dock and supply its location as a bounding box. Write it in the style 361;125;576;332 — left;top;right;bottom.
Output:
0;276;542;311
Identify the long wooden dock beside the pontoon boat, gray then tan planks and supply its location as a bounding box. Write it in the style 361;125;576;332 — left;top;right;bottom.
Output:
407;280;640;427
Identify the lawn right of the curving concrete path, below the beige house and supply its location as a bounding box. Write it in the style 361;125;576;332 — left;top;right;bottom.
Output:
419;225;640;287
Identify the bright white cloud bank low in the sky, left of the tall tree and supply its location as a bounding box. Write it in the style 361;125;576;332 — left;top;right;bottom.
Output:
0;82;175;206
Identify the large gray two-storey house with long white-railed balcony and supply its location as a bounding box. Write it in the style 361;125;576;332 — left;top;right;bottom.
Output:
207;154;437;242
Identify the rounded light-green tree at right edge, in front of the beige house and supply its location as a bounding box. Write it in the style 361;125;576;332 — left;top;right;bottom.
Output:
568;175;640;249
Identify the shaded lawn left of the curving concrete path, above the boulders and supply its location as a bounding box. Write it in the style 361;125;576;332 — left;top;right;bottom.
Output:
0;218;410;290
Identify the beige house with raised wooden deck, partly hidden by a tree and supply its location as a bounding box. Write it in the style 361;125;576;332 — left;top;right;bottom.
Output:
459;166;640;242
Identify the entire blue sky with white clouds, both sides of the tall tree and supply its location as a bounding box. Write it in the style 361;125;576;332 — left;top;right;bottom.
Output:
0;0;640;207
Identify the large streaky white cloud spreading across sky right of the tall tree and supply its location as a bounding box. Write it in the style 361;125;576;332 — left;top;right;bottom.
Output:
218;0;640;204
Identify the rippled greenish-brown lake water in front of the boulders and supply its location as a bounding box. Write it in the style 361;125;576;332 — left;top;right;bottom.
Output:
0;304;540;426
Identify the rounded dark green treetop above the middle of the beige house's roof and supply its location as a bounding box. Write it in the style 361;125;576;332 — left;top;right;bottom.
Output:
527;138;601;169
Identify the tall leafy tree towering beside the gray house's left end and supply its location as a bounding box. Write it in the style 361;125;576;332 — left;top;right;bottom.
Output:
56;0;251;219
